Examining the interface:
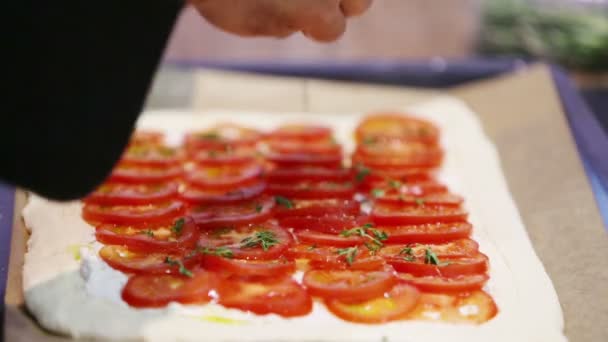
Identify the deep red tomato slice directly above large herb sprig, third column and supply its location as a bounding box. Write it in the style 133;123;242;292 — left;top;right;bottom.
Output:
279;215;370;233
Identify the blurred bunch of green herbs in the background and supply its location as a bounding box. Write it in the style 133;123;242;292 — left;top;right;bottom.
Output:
479;0;608;71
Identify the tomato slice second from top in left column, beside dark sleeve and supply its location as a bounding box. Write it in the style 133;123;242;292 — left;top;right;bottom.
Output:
120;145;181;167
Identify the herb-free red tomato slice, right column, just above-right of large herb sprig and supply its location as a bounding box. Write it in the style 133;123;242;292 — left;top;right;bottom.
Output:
371;204;468;226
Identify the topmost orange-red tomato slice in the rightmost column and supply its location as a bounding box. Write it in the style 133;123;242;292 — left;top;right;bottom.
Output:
355;113;439;144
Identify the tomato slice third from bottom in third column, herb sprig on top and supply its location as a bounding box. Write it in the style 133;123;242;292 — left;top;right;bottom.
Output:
287;244;386;271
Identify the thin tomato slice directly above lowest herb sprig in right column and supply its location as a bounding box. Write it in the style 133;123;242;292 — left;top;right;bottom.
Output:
378;239;479;259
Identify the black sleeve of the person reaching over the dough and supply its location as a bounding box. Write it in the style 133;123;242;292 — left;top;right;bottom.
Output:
0;0;182;200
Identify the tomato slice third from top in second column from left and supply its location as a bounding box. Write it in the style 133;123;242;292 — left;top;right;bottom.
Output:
186;163;264;190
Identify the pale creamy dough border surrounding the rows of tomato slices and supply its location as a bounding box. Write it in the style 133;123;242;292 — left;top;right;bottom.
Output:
23;96;567;342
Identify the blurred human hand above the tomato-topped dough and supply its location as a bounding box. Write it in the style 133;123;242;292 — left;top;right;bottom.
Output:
190;0;372;42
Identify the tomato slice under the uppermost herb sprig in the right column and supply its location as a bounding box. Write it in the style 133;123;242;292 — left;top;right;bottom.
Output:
368;180;448;196
